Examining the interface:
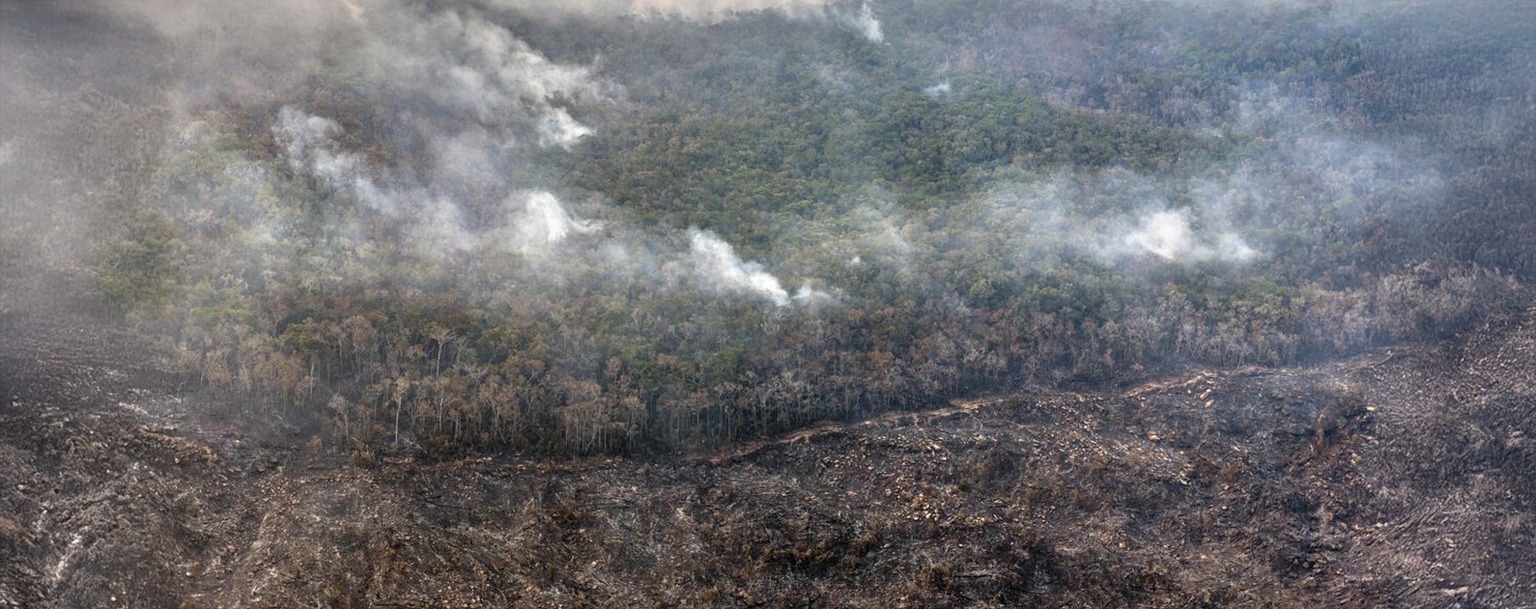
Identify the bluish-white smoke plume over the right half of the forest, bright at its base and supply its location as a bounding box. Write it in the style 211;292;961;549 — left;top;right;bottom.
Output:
946;77;1447;269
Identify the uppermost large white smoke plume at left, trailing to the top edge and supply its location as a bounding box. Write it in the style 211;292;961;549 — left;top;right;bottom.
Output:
108;0;607;154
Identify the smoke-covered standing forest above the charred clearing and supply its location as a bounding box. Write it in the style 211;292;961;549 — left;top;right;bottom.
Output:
0;0;1536;457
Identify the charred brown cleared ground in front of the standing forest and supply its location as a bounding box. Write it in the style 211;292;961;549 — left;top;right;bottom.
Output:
0;284;1536;607
